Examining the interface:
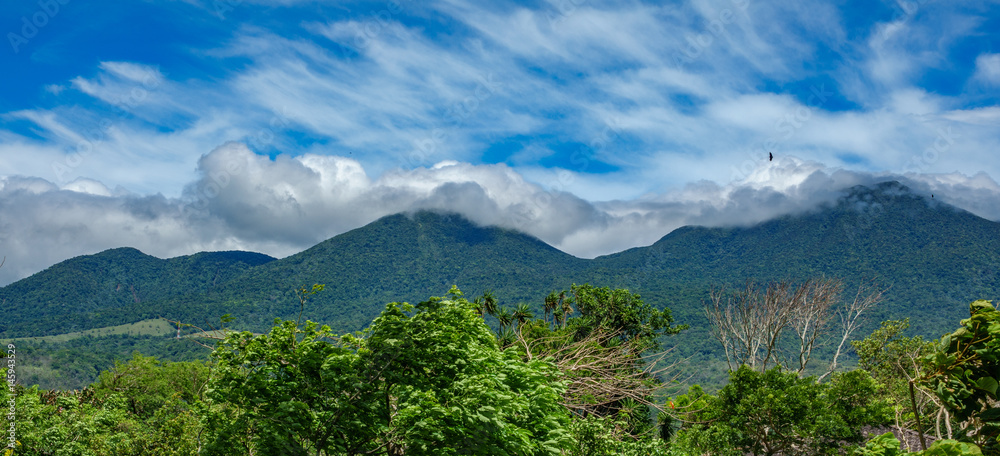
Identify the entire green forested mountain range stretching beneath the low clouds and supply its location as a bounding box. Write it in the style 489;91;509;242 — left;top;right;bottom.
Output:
0;182;1000;346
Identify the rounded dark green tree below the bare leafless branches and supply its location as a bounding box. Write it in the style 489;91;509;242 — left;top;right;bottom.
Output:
675;365;889;455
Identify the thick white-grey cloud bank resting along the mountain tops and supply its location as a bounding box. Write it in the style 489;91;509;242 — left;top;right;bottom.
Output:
0;143;1000;284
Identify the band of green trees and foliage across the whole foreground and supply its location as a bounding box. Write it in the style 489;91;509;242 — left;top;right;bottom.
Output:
7;285;1000;456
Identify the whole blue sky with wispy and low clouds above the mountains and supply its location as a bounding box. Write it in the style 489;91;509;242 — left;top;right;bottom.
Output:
0;0;1000;284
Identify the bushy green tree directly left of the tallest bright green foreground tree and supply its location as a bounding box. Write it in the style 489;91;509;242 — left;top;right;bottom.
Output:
204;321;374;455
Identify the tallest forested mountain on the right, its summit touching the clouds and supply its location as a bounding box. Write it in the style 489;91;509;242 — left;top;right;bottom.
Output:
594;182;1000;337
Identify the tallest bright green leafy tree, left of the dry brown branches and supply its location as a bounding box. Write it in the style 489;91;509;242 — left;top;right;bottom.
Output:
359;288;570;455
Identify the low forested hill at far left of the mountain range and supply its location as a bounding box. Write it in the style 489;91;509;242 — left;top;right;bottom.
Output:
0;248;274;337
